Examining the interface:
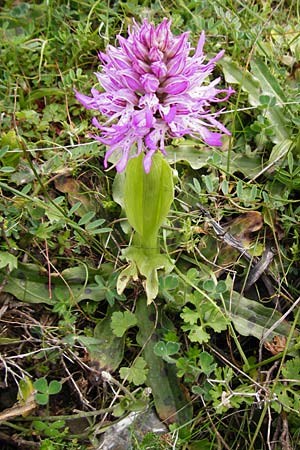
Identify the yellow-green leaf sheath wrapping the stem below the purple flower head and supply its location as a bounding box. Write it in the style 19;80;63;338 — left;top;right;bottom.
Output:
117;154;174;304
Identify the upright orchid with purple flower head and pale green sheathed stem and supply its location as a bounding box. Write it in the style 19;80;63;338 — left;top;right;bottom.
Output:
76;18;234;303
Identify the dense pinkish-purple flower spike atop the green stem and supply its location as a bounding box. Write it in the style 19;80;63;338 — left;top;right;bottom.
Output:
76;18;234;173
